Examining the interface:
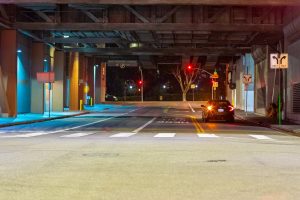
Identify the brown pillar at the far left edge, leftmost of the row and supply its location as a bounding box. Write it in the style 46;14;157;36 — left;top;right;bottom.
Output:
0;30;17;117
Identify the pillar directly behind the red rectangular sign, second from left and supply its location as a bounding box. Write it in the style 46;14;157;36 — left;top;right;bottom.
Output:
31;43;45;113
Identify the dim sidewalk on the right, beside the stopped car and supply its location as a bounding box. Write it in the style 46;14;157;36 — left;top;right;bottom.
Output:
235;110;300;136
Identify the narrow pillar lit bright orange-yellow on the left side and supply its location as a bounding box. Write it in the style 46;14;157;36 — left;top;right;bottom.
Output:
69;52;79;110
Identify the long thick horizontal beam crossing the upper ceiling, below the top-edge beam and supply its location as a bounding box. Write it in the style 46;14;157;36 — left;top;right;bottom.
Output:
14;22;282;32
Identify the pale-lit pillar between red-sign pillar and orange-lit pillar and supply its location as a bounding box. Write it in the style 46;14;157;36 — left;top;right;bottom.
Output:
53;51;65;112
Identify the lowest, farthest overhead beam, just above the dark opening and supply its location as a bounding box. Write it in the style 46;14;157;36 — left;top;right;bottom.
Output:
64;47;251;56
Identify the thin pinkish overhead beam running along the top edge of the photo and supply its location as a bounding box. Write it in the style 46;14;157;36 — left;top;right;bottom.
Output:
0;0;300;6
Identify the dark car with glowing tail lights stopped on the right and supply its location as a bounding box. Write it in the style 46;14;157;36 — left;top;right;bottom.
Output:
201;100;234;122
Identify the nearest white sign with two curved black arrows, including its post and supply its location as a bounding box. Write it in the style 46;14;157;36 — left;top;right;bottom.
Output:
270;53;289;125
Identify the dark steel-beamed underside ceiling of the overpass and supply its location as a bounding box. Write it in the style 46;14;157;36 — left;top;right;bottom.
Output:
0;0;300;65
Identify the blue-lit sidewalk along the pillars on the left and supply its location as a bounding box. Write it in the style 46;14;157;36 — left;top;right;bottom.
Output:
0;111;89;128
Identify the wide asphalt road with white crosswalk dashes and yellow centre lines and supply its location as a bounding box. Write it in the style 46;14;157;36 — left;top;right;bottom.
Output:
0;106;300;200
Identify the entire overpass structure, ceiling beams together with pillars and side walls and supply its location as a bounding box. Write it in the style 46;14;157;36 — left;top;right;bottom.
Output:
0;0;300;120
